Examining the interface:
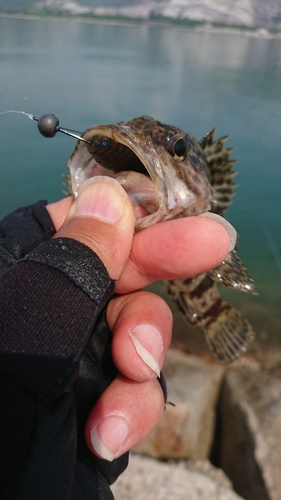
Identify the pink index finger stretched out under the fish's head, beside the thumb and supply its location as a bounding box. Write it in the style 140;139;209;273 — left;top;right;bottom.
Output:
116;217;229;293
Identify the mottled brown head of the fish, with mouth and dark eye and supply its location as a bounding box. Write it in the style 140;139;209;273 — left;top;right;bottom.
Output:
68;116;212;231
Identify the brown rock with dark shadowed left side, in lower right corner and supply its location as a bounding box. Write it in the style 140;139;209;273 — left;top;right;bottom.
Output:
219;369;281;500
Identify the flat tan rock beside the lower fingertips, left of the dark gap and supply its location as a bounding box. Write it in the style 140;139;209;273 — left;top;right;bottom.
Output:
134;349;225;460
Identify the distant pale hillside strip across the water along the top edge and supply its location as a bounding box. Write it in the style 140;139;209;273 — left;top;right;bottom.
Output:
0;0;281;30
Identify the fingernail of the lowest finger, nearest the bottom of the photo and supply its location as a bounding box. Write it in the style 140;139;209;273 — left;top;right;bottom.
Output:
91;415;129;462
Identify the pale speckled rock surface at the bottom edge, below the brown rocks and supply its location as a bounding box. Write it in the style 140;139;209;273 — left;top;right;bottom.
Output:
111;455;244;500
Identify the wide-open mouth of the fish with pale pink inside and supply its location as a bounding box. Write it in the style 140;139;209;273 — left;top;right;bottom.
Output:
68;126;162;230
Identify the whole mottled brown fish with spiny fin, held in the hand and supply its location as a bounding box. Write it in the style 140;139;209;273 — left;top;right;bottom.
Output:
67;116;257;363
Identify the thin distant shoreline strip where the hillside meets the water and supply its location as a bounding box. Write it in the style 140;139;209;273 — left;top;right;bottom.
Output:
0;12;281;40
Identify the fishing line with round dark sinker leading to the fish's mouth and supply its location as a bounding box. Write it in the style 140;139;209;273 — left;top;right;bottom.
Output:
0;109;90;144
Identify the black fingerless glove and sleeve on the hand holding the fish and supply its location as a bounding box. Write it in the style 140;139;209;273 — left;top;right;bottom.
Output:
0;201;128;500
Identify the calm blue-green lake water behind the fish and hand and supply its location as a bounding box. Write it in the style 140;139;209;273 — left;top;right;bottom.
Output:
0;17;281;360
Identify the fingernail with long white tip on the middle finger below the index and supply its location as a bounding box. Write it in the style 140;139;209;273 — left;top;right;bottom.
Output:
129;324;163;377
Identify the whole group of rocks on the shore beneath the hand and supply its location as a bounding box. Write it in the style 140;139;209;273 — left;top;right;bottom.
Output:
112;348;281;500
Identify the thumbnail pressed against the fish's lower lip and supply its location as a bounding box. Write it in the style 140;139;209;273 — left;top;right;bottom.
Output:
75;176;126;224
